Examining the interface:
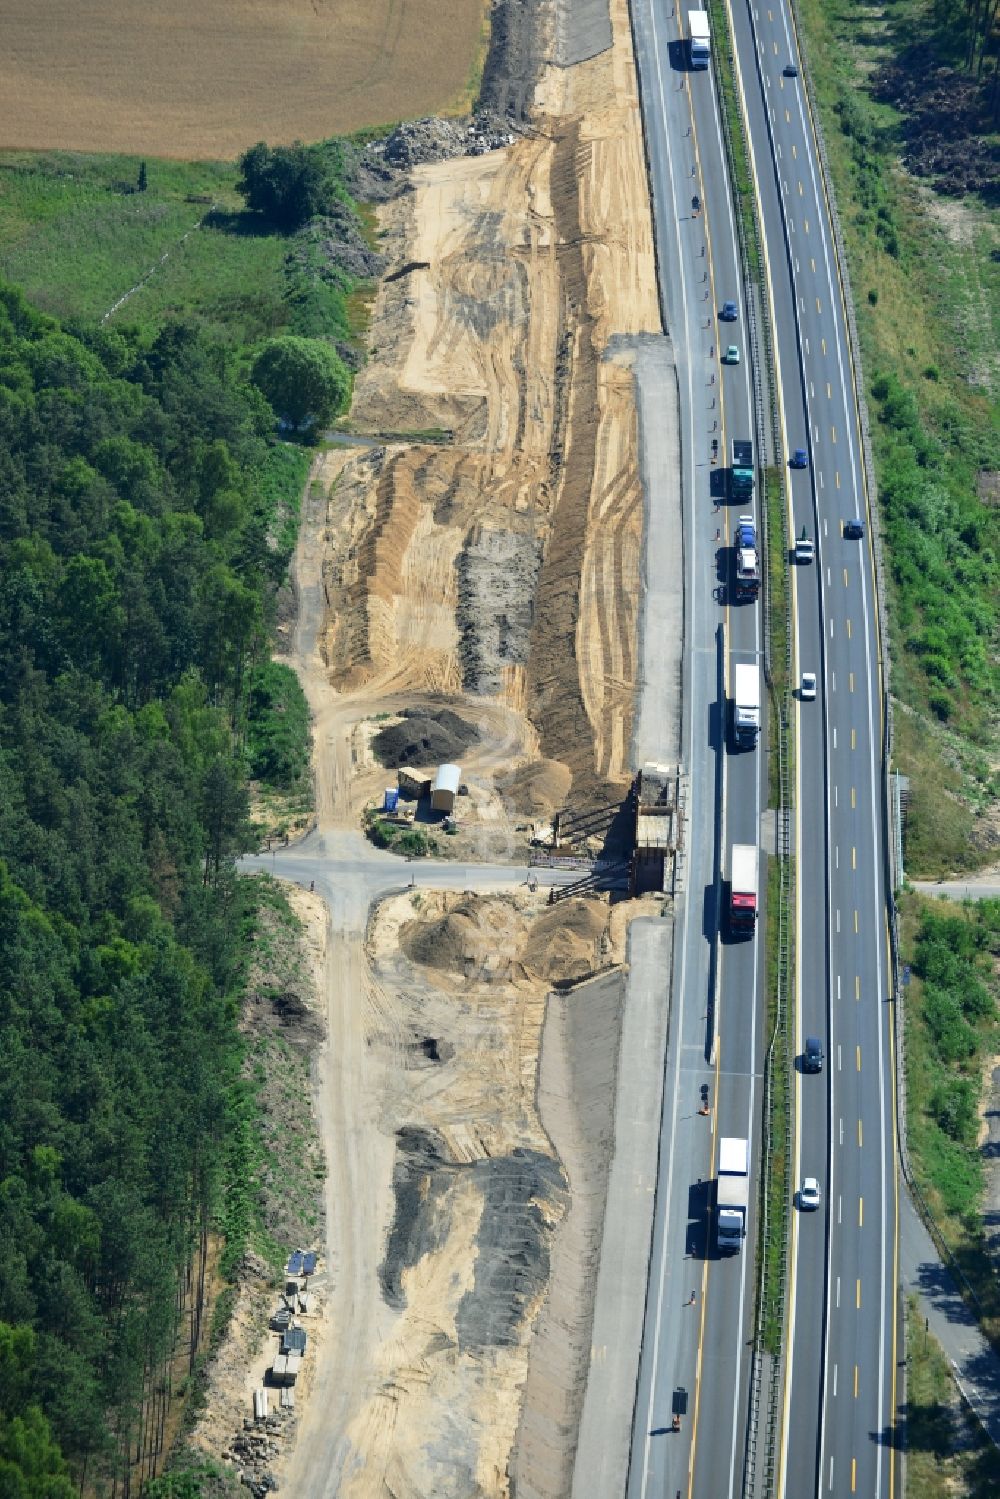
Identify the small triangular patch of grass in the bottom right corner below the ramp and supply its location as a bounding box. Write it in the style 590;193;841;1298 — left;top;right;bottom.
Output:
906;1297;1000;1499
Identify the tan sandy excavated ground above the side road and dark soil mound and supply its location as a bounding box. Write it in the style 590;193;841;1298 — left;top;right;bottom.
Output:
332;0;658;799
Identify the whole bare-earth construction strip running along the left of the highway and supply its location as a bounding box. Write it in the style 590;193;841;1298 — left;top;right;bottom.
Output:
193;0;660;1499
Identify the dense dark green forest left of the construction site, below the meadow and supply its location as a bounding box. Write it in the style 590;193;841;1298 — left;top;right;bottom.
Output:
0;285;310;1499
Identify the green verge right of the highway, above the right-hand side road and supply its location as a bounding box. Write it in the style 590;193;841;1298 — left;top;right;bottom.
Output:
801;0;1000;875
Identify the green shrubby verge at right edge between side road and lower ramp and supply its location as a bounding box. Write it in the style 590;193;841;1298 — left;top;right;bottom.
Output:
901;895;1000;1348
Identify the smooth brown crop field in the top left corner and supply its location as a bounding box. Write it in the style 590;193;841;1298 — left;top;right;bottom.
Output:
0;0;486;160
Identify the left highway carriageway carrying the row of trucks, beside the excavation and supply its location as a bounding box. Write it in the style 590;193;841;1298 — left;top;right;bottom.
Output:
628;0;763;1499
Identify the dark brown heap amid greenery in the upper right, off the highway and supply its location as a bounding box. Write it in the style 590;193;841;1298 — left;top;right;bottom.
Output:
873;43;1000;204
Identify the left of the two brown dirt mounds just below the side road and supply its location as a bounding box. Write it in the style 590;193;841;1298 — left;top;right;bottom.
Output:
399;895;525;980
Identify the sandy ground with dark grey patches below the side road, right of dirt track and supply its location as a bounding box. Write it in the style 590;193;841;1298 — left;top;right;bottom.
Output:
328;892;609;1499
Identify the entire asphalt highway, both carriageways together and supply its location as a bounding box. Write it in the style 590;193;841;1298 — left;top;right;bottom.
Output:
628;0;898;1499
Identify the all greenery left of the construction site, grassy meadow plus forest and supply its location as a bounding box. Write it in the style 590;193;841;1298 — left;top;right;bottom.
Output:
0;119;379;1499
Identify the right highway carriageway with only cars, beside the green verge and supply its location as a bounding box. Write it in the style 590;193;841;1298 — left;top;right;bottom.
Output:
733;4;897;1496
